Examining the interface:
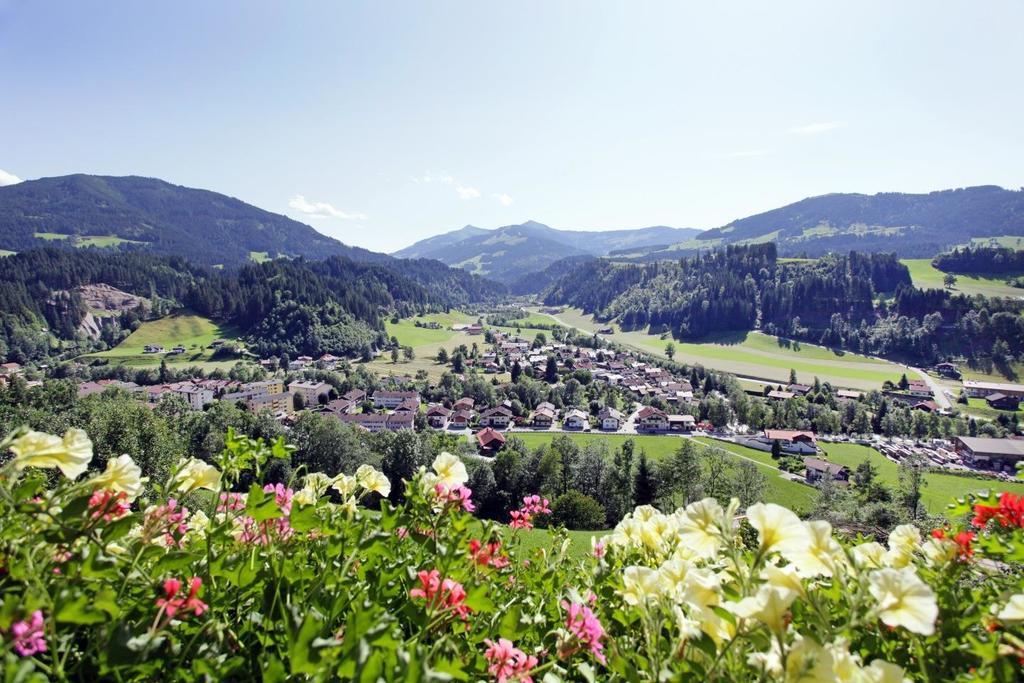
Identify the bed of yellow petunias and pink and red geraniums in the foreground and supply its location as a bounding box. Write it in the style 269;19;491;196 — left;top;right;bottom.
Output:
0;430;1024;681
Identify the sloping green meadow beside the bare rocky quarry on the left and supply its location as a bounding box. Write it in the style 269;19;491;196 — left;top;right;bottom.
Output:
84;312;238;370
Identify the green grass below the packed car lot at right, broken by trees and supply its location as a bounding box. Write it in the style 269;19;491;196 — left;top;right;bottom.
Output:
819;443;1024;514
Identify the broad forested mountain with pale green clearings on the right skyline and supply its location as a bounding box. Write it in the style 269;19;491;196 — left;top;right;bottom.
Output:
633;185;1024;260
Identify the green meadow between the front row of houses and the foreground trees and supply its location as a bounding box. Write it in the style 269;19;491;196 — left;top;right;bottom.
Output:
514;432;814;510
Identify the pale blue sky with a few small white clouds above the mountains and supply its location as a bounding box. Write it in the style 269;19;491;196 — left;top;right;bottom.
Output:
0;0;1024;252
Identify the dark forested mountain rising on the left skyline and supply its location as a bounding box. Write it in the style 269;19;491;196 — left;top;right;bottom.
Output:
0;174;390;265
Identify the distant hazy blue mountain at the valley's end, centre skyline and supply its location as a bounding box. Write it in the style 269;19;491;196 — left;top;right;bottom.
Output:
393;220;699;284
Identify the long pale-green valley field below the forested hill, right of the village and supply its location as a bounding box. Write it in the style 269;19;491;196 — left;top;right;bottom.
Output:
532;309;905;389
